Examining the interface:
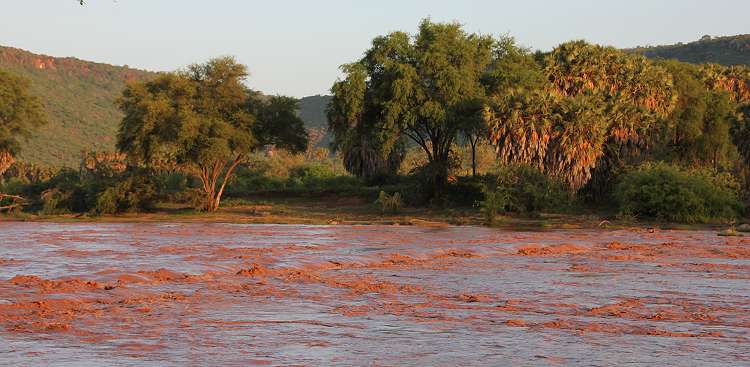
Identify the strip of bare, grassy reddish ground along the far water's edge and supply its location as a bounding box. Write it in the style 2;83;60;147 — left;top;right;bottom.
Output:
0;196;740;230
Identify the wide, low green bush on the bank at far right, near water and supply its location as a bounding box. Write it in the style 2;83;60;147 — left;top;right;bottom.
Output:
615;163;742;223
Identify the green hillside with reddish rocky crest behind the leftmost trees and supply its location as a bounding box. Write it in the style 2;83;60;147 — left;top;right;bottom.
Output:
0;47;156;167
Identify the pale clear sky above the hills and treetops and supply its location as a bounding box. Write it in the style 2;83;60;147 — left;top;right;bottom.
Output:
0;0;750;97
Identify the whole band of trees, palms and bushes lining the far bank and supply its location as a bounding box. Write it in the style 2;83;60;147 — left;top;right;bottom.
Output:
0;19;750;230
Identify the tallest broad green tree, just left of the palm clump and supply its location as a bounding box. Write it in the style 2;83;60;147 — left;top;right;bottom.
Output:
329;20;494;197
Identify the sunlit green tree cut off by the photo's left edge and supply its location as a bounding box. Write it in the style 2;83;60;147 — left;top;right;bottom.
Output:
0;70;46;176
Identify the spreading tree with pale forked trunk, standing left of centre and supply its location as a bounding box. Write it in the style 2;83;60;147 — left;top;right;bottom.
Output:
117;57;257;211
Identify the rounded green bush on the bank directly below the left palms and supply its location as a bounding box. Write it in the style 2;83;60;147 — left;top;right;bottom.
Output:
480;164;572;223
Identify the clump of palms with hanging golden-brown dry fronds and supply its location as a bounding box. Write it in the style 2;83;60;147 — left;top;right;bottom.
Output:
484;41;676;191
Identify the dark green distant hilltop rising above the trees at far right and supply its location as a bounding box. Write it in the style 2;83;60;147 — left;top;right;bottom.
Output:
628;34;750;66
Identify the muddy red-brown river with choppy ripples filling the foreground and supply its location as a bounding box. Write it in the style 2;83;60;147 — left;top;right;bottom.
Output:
0;223;750;366
